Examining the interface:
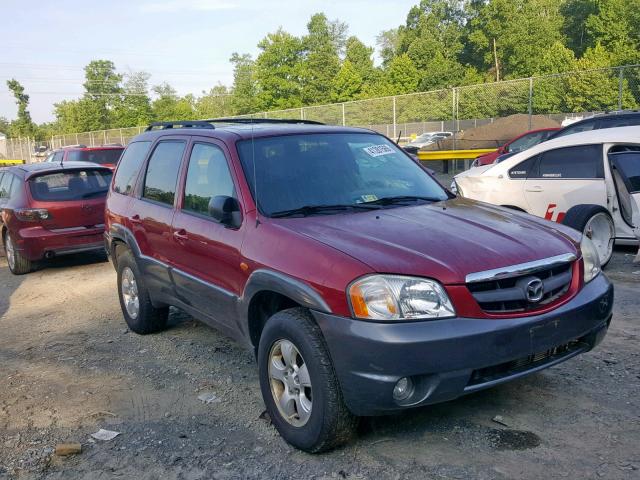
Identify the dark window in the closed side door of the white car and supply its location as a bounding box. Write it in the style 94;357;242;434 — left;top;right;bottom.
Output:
530;145;604;179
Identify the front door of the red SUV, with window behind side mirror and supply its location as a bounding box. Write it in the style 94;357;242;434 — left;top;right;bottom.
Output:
173;139;246;334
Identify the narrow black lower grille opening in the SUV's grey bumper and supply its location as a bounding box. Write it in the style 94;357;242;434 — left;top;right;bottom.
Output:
467;340;587;387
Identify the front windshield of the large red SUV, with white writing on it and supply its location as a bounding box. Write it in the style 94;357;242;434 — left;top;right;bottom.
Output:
238;133;448;216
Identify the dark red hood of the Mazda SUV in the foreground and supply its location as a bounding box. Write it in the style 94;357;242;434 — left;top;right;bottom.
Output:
278;198;577;284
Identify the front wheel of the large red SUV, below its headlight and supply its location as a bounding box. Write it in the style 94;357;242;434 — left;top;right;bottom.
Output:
258;308;357;453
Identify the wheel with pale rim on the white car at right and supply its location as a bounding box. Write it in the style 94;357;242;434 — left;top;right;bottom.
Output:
562;205;616;268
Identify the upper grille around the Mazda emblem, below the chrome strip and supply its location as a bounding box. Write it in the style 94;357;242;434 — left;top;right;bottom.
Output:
467;262;573;313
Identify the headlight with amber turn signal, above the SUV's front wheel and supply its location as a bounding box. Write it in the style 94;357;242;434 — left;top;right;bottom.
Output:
347;275;456;320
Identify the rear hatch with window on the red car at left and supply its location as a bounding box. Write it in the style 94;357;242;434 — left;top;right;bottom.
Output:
27;168;112;230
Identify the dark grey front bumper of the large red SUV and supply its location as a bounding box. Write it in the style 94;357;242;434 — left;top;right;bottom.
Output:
314;274;613;416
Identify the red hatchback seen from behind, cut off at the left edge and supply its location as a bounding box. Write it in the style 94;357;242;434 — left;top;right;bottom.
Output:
0;162;112;275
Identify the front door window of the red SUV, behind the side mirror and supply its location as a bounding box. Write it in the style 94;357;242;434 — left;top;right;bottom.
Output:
182;143;235;215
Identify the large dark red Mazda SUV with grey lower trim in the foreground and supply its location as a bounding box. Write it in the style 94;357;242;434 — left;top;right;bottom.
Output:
105;120;613;452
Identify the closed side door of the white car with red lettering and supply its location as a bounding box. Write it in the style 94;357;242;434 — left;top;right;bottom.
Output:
524;144;611;223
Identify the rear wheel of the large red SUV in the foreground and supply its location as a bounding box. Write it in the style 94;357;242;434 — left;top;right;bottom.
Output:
118;250;169;335
